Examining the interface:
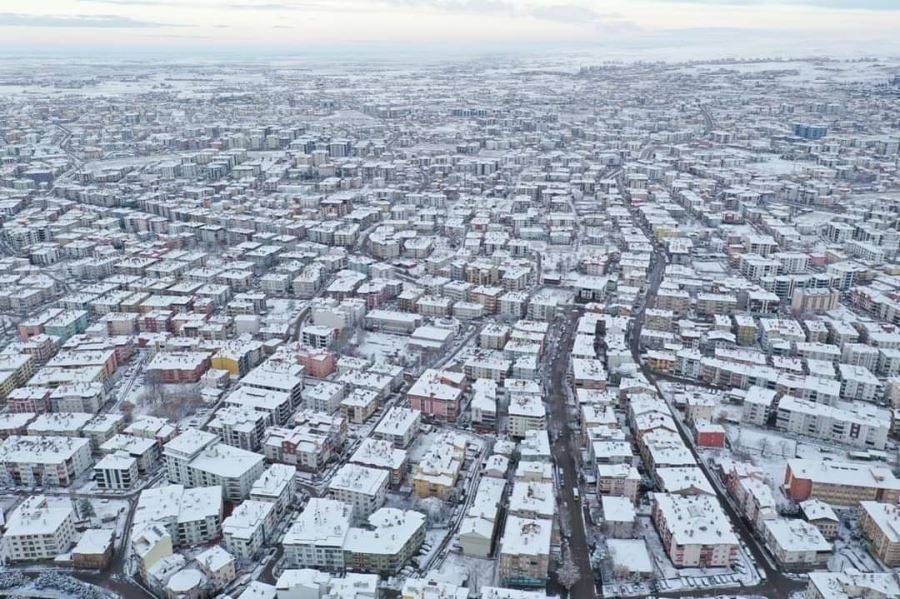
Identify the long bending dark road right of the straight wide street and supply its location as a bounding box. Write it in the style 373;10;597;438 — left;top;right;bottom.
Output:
629;226;806;599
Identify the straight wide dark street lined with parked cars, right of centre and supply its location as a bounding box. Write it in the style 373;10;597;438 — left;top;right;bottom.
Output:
549;310;596;599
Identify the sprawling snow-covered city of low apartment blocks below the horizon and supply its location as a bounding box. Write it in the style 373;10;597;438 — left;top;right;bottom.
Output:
0;7;900;599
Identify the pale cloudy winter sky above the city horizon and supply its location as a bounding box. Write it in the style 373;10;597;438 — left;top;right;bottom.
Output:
0;0;900;59
